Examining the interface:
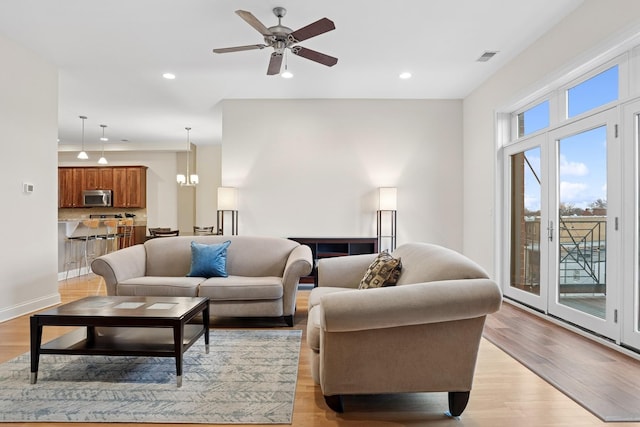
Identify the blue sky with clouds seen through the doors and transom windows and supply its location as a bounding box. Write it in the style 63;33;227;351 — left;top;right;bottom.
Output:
524;66;618;211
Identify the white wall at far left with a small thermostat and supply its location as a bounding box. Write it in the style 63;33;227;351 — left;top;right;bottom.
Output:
0;32;60;321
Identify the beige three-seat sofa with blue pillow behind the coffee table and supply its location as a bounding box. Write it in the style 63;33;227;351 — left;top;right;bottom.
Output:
91;236;312;326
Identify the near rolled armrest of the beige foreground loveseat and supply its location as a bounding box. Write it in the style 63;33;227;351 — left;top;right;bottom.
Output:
320;279;502;332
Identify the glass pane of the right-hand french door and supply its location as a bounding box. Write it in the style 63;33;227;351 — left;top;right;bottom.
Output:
558;126;607;319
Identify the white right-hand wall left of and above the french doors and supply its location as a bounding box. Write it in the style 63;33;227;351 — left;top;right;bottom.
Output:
464;0;640;272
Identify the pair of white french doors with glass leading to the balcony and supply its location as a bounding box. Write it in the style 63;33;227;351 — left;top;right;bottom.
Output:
503;109;622;341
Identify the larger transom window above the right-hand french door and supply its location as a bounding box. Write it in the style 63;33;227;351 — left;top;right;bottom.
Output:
567;65;618;118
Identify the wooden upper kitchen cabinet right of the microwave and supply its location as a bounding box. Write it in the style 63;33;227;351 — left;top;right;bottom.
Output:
113;166;147;208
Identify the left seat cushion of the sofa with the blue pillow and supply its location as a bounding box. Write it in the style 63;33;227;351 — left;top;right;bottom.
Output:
116;276;205;297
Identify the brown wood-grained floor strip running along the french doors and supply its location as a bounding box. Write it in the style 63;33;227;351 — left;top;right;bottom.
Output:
484;304;640;422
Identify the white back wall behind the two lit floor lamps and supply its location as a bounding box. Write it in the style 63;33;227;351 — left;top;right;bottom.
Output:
222;99;462;250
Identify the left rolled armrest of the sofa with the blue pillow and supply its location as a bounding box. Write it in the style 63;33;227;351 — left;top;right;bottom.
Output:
91;245;147;295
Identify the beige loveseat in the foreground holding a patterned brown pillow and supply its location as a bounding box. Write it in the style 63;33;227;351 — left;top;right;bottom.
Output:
307;243;502;417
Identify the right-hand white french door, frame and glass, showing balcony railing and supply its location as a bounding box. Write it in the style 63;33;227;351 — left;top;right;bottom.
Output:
548;109;622;340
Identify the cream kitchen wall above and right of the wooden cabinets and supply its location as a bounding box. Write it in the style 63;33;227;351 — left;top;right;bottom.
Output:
56;151;178;228
